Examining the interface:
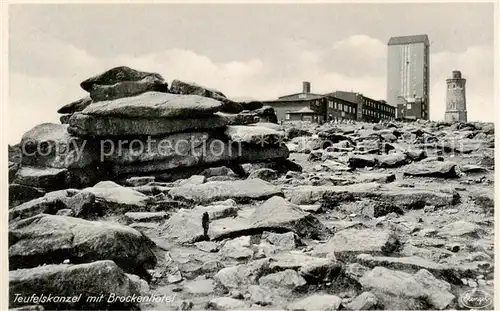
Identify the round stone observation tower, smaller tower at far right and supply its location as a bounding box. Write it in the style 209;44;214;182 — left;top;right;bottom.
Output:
444;70;467;122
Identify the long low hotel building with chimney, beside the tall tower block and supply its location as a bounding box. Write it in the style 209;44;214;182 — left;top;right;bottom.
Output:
263;82;395;123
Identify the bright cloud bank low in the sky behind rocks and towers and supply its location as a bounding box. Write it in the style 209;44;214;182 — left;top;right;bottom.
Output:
9;35;494;143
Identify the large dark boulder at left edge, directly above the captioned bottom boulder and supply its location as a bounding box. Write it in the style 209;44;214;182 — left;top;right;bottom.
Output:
9;214;156;277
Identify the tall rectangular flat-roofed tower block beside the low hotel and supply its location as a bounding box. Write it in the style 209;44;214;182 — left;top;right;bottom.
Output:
387;35;430;120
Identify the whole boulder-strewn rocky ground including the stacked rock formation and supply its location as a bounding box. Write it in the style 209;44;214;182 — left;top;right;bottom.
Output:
9;67;495;310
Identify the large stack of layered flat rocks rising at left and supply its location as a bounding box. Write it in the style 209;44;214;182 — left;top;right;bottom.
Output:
11;67;288;196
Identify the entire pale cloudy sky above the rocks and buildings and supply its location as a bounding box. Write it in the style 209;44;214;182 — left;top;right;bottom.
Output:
8;3;494;143
